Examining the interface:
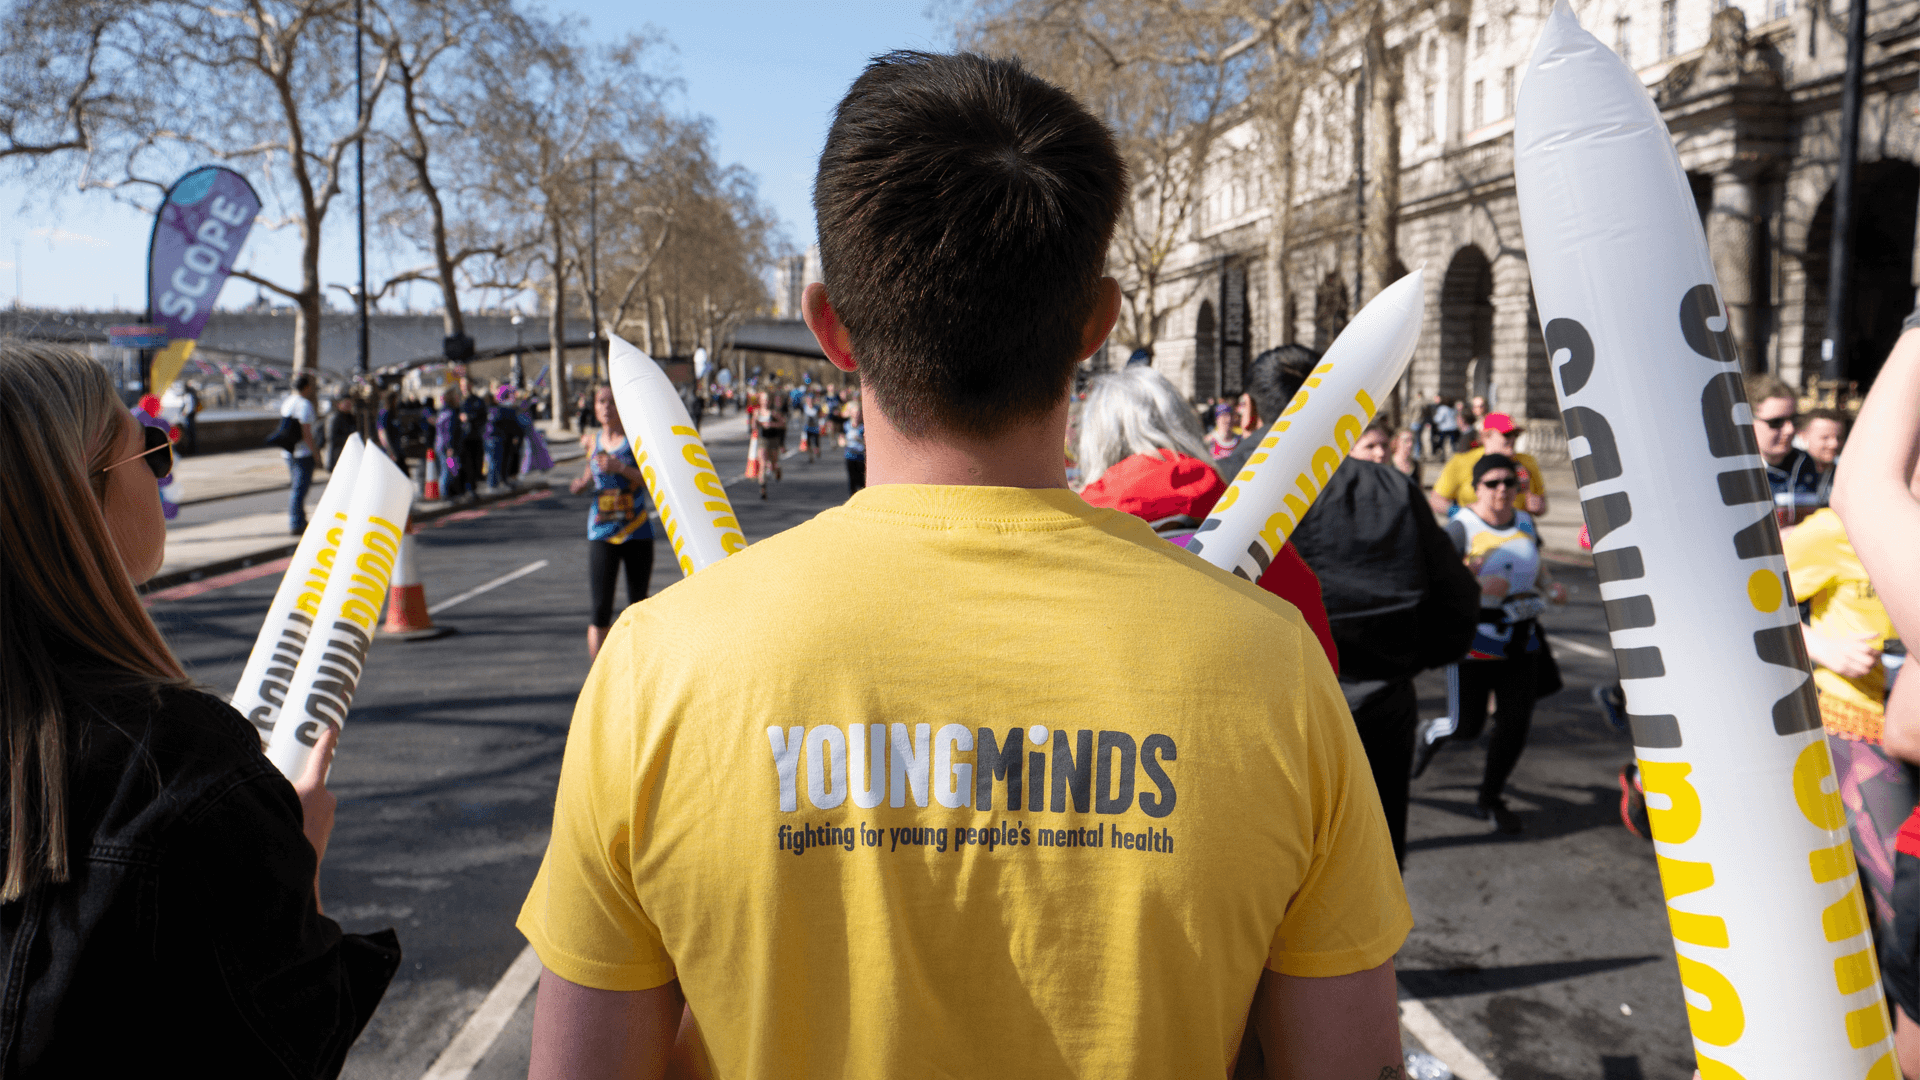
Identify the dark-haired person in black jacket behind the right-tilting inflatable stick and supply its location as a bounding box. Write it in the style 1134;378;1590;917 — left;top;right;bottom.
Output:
1219;346;1480;867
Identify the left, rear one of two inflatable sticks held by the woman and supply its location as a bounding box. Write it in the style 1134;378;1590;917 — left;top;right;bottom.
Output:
230;432;365;744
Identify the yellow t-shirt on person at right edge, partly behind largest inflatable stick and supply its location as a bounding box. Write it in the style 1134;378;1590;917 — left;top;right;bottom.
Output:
1786;509;1897;715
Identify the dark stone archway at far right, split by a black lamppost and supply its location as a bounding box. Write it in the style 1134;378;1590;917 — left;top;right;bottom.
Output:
1801;160;1920;390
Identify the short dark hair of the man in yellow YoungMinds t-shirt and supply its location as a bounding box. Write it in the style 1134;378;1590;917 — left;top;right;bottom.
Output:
814;52;1127;436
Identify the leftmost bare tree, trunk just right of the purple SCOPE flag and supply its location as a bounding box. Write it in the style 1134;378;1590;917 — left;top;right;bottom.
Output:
8;0;388;369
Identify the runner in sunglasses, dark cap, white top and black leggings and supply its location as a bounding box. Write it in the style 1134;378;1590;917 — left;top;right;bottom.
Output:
1413;454;1567;832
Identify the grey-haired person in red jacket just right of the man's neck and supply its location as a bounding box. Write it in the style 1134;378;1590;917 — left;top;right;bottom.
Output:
1079;365;1340;675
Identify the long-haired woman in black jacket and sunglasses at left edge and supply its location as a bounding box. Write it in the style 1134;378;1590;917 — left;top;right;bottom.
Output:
0;342;399;1076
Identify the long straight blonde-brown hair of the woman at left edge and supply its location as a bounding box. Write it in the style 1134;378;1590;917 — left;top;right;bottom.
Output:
0;340;188;901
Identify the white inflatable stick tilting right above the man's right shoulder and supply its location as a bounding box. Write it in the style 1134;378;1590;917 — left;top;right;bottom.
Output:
1187;269;1427;580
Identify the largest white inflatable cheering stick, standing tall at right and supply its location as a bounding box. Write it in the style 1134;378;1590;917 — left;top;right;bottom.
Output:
1515;0;1899;1080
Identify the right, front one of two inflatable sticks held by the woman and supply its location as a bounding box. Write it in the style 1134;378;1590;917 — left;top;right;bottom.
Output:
267;454;413;778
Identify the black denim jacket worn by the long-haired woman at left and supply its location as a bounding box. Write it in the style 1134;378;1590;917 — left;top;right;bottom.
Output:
0;690;399;1080
